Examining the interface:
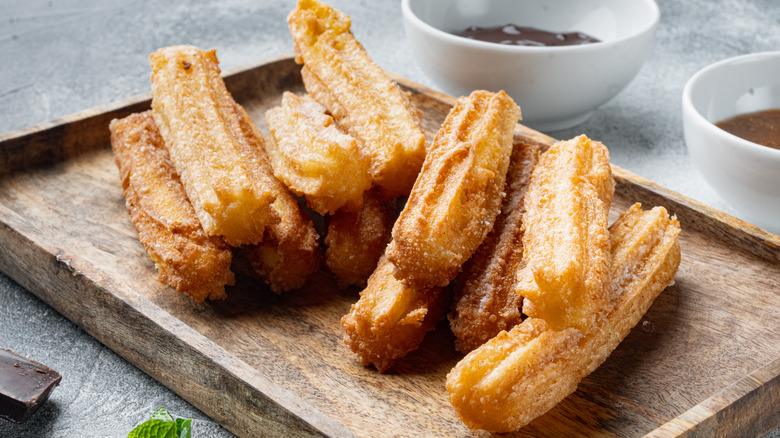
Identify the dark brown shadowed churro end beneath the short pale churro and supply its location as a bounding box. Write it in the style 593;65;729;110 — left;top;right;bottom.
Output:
325;190;395;288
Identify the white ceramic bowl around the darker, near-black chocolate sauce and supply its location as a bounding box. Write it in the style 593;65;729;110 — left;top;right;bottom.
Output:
402;0;660;131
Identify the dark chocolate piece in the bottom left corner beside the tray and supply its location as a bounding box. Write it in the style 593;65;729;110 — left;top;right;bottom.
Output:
0;348;62;423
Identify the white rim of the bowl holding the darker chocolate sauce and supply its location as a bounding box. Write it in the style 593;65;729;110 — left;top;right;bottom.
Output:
401;0;661;53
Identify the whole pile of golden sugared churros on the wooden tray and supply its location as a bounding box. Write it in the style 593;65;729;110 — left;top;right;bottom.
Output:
110;0;680;432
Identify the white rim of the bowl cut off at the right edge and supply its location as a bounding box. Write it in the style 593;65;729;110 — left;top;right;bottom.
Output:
682;51;780;160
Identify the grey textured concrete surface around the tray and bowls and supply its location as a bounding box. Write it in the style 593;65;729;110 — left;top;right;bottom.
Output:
0;0;780;438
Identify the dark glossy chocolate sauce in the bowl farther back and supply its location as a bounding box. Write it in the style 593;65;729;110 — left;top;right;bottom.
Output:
457;24;601;46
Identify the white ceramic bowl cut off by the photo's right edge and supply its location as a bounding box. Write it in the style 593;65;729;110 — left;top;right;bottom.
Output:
682;52;780;234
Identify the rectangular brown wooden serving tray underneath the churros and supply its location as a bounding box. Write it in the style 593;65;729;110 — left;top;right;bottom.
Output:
0;55;780;437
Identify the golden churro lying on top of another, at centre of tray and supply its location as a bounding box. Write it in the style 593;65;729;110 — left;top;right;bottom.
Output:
386;91;520;289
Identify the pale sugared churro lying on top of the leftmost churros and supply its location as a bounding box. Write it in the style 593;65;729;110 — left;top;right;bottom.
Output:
149;46;275;250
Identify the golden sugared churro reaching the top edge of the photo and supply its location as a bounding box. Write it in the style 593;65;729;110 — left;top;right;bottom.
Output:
287;0;425;199
